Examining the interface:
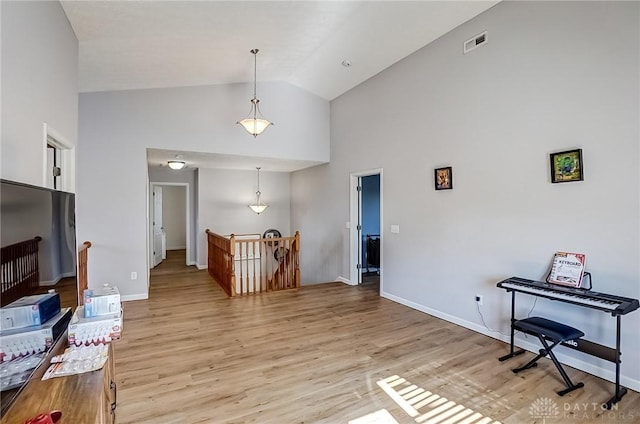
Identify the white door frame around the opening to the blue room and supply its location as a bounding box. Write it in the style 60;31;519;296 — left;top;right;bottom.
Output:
349;168;384;293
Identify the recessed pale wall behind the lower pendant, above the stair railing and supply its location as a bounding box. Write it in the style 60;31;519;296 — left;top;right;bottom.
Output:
198;169;295;269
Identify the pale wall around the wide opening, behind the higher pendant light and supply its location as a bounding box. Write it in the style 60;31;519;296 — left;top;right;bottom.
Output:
77;83;329;299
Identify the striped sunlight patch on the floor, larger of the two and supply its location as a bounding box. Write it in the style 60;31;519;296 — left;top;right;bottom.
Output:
377;375;500;424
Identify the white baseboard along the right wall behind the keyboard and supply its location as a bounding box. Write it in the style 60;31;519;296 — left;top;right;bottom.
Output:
380;292;640;392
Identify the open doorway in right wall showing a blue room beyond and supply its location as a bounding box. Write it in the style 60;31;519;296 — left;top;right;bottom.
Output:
349;169;383;291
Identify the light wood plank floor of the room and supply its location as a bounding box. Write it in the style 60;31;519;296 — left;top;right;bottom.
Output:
115;253;640;424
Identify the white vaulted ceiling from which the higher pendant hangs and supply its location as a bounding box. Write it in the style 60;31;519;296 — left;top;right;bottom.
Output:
61;0;498;171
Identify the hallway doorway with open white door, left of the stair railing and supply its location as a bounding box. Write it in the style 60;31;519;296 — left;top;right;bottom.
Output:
149;183;191;268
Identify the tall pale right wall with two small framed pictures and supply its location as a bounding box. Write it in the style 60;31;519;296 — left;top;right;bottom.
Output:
291;2;640;390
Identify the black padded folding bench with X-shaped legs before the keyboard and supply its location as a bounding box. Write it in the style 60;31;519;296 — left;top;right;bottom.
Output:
513;317;584;396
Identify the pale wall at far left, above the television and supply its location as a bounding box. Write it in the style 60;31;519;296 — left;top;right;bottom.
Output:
0;1;78;186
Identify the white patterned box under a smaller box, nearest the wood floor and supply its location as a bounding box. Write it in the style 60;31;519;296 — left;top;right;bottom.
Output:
68;306;122;346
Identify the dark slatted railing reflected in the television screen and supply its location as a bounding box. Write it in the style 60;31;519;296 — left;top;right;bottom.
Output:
0;236;42;306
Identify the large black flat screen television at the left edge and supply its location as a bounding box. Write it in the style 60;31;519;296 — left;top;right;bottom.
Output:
0;180;78;416
